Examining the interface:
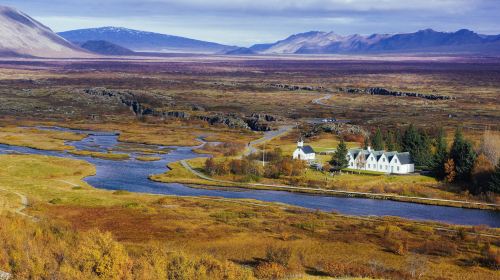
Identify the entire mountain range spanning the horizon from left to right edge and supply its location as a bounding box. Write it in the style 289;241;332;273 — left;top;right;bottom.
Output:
0;6;500;58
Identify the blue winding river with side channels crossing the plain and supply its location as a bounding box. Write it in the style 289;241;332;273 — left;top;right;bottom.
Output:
0;128;500;227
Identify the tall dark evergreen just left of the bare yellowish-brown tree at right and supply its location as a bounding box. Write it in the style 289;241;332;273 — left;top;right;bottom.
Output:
450;128;476;180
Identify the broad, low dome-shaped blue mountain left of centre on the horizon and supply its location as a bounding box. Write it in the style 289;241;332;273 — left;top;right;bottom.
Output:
58;27;235;53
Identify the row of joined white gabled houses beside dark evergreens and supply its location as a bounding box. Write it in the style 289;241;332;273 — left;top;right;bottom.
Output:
347;147;415;174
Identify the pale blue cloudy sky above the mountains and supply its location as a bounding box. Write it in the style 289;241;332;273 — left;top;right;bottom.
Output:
0;0;500;46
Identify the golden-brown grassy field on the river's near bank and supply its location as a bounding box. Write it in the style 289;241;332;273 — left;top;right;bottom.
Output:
0;155;500;279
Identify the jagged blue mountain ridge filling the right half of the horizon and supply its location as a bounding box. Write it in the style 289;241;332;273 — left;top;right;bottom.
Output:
250;29;500;54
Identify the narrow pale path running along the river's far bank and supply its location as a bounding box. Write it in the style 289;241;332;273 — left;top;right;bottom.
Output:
181;160;500;208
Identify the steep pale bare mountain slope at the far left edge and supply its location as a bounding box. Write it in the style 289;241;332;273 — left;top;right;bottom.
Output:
0;6;91;58
